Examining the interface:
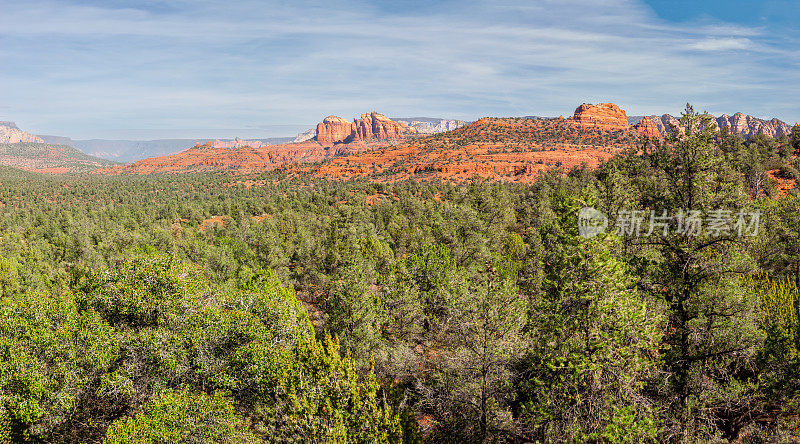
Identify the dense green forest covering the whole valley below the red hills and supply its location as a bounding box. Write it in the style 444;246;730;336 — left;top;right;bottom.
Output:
0;107;800;443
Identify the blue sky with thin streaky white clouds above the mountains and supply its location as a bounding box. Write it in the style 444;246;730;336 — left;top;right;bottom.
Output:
0;0;800;139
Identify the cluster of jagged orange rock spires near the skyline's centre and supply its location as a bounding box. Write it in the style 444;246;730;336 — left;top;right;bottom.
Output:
315;111;416;146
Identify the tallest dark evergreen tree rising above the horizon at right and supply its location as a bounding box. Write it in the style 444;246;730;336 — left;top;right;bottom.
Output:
631;105;762;440
